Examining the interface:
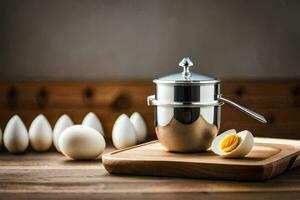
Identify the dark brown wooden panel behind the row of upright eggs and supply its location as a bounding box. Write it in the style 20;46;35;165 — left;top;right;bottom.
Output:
0;80;300;138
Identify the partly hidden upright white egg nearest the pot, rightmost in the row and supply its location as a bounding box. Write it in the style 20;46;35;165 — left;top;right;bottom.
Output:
130;112;147;143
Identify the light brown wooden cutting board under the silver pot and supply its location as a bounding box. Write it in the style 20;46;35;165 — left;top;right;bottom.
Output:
102;138;300;181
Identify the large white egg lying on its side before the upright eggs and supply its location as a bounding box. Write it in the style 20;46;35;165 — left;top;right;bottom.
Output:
58;125;105;160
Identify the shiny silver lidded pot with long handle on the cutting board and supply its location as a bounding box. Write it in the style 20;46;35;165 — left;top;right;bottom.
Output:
147;58;267;152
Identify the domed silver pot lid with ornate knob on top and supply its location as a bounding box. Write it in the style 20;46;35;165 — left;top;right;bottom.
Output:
153;57;220;84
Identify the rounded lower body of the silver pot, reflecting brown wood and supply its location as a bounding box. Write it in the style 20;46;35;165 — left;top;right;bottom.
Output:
155;106;220;152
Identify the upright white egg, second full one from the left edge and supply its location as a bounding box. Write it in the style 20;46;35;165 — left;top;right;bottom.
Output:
28;114;52;151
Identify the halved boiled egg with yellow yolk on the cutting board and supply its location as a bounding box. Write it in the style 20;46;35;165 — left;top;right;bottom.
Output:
211;129;254;158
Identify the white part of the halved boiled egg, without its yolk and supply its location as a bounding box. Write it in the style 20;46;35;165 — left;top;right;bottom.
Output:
212;129;254;158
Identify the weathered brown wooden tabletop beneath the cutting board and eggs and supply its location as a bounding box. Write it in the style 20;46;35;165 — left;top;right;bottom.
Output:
0;145;300;200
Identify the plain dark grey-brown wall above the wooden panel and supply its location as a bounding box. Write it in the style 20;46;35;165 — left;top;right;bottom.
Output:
0;0;300;80
